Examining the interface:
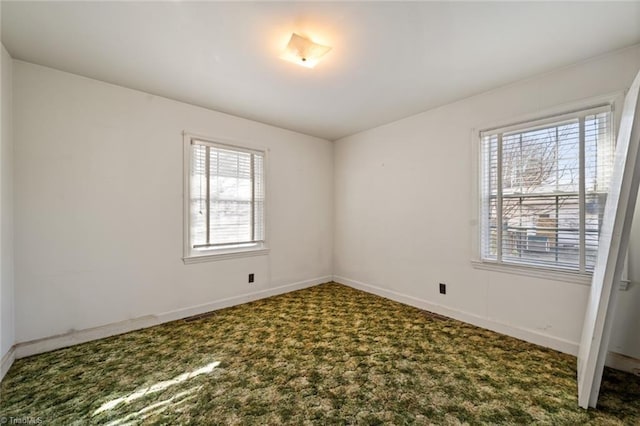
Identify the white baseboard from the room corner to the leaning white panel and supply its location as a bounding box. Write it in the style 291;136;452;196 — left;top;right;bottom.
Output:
333;275;580;356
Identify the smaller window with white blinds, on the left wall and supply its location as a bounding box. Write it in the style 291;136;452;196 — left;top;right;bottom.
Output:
185;135;265;262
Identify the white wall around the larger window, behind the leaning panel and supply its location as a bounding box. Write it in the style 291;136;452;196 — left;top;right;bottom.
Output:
334;46;640;358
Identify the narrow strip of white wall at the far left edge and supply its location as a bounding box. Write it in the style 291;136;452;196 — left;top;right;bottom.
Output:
0;46;14;362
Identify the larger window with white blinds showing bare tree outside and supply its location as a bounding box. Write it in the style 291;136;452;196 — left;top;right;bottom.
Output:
480;105;614;274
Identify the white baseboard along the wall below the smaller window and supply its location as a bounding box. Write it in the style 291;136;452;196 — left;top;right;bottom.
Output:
14;275;333;360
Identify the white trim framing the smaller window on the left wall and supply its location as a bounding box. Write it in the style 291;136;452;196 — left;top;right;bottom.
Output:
182;131;269;265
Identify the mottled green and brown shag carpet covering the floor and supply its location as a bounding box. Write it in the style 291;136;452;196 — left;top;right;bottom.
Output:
0;283;640;425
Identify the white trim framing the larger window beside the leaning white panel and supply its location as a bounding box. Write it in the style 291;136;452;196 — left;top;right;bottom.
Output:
469;92;624;285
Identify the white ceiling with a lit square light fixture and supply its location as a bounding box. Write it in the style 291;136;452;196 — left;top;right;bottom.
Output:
2;1;640;140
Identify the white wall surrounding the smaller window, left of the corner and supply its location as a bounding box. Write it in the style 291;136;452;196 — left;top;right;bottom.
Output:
13;61;333;342
